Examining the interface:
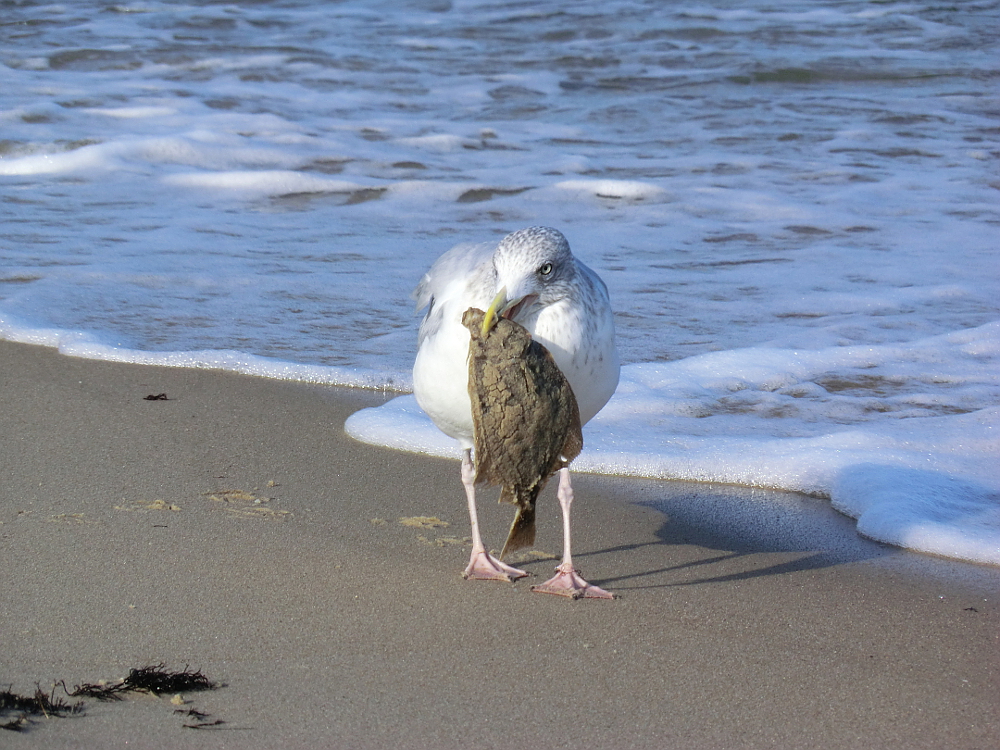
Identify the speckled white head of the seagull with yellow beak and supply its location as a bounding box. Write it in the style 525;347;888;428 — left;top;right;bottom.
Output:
483;227;576;335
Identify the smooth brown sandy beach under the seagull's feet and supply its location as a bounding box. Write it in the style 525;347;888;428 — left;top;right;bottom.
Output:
0;342;1000;748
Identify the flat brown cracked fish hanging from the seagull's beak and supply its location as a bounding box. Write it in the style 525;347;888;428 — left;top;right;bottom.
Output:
462;307;583;558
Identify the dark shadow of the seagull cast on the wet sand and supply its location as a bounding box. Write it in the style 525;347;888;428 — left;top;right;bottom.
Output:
574;480;903;591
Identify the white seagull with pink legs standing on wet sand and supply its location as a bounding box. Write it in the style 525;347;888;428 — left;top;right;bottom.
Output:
413;227;621;598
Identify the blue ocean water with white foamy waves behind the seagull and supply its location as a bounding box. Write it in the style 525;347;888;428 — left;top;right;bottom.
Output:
0;0;1000;564
